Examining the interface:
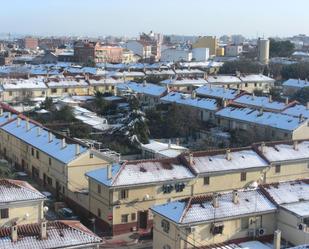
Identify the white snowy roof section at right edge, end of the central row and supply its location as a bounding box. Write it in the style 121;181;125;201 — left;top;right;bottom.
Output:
258;141;309;162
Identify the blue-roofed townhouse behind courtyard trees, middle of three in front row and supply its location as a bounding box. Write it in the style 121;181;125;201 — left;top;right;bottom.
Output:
161;91;221;121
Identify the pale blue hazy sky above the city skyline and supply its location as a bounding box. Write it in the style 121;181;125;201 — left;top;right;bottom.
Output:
0;0;309;38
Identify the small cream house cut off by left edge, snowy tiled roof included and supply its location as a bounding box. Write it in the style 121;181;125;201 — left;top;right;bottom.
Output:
0;179;46;227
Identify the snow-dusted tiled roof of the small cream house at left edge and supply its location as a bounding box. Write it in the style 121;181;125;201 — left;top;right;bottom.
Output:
0;179;45;206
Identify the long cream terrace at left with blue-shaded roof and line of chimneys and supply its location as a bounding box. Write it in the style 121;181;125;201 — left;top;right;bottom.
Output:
0;109;112;213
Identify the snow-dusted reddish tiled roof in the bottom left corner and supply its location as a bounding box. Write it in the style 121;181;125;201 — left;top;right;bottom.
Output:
0;220;102;249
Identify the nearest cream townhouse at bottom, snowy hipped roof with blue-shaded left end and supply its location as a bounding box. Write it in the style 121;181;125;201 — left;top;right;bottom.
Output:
151;189;276;249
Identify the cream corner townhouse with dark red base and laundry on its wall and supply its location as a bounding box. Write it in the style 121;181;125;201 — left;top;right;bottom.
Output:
86;158;194;234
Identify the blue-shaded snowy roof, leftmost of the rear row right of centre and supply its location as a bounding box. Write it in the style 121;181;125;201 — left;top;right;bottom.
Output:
196;85;239;99
